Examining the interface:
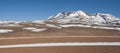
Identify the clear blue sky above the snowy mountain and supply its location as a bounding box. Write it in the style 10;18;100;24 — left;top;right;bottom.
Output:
0;0;120;21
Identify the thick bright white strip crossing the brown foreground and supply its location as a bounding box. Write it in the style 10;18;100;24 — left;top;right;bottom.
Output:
0;42;120;48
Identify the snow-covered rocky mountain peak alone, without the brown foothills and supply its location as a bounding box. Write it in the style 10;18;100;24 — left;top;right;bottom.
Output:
48;11;120;25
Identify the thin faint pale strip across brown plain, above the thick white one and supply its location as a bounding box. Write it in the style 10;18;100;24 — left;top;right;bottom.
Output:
0;36;120;40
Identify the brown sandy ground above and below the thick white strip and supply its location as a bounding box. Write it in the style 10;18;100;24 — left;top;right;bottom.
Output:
0;38;120;53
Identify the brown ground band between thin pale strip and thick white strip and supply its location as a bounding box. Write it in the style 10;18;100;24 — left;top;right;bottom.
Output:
0;37;120;45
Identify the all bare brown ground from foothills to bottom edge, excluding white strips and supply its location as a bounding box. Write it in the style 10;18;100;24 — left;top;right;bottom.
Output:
0;27;120;53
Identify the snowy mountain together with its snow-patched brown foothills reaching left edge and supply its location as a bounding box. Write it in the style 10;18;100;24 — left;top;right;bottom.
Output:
0;11;120;33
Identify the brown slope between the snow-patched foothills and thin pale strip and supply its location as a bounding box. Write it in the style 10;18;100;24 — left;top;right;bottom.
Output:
0;27;120;38
